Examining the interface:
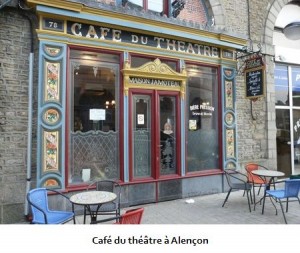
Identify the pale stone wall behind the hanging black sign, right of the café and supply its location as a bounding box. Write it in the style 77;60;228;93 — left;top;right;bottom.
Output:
220;0;277;168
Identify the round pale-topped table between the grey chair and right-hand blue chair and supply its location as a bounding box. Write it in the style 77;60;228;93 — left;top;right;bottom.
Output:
251;170;285;214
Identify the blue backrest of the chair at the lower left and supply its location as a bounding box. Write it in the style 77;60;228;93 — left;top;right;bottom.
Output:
27;188;49;221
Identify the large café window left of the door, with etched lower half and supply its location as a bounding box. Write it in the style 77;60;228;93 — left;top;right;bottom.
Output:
68;50;119;184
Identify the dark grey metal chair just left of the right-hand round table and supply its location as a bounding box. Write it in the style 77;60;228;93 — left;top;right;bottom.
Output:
222;169;252;212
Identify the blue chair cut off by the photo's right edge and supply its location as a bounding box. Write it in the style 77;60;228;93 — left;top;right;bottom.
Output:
263;179;300;224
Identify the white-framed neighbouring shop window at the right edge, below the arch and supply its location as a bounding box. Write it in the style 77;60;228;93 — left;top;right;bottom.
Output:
275;64;300;176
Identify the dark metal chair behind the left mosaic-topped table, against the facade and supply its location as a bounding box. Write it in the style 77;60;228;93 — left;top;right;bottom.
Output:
83;180;121;223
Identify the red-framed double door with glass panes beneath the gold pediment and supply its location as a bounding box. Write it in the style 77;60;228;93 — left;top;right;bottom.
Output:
129;89;180;181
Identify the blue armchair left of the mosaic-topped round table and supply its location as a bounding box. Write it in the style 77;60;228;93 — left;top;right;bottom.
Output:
27;188;75;224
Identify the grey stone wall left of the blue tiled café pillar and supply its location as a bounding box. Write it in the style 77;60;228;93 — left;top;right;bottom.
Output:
0;7;37;223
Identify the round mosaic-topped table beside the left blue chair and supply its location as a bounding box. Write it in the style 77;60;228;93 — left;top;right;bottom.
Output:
70;191;117;224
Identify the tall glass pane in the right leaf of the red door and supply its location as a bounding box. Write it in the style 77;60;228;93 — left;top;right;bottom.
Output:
159;96;177;175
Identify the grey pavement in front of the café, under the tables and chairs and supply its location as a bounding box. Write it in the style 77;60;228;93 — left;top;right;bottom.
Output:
71;191;300;224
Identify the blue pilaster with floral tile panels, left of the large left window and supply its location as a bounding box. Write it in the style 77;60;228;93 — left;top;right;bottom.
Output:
37;40;67;189
